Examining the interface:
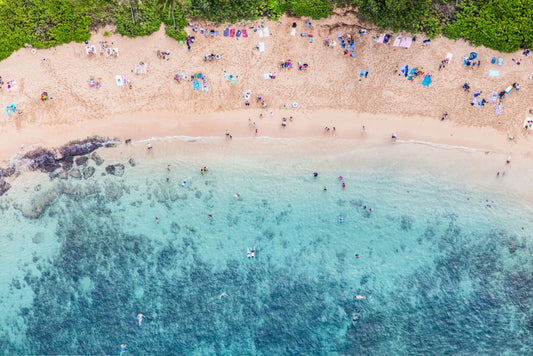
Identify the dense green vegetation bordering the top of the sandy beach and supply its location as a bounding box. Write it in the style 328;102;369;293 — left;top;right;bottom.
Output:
0;0;533;60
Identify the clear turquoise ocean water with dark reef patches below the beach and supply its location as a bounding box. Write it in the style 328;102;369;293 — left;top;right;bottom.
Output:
0;139;533;355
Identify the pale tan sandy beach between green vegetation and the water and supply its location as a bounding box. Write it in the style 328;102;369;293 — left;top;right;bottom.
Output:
0;13;533;162
